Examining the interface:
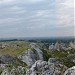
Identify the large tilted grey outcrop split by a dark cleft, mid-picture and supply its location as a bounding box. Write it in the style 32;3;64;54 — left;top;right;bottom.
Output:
18;43;44;66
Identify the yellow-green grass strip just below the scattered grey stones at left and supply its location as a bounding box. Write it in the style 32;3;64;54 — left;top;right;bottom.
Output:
0;47;28;57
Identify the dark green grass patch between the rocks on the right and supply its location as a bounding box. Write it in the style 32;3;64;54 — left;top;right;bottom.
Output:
42;49;75;67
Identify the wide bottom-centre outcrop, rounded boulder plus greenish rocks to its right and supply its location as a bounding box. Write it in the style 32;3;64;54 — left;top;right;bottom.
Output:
26;60;66;75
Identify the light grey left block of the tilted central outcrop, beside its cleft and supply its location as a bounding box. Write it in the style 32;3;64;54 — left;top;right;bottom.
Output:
18;49;36;66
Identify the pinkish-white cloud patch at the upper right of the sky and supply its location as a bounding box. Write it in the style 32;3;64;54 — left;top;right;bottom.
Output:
56;0;74;26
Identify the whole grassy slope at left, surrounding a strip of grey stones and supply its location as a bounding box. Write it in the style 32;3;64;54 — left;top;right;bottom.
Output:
0;41;29;57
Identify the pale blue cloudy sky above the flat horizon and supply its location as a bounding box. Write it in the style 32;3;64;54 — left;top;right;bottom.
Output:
0;0;75;38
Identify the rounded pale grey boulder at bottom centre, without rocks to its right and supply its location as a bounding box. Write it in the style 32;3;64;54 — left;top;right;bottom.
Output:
26;60;49;75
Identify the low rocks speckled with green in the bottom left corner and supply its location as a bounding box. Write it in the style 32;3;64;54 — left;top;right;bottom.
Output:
0;64;25;75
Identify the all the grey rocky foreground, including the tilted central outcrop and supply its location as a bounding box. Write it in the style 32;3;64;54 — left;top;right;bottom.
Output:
0;43;75;75
